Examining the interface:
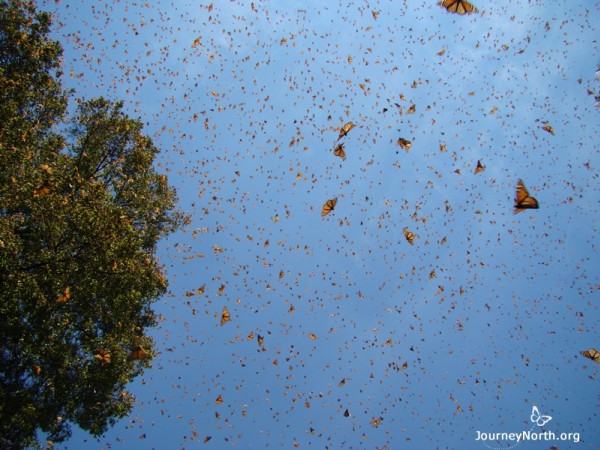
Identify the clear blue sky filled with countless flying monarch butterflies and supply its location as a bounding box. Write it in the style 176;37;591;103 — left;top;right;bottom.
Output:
39;0;600;449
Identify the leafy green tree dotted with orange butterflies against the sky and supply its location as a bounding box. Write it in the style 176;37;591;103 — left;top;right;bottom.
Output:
0;0;185;449
